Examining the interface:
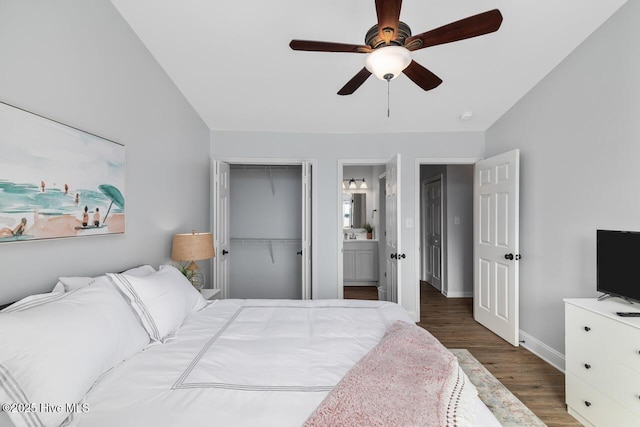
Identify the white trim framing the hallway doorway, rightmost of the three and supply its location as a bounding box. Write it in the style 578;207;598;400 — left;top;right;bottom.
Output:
413;157;484;322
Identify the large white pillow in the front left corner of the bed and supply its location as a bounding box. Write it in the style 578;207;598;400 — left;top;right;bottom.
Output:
0;276;149;427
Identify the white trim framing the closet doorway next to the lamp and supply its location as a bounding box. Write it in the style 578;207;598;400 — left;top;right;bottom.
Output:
209;156;318;300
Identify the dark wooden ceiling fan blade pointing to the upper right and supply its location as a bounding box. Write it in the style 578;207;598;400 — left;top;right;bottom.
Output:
405;9;502;50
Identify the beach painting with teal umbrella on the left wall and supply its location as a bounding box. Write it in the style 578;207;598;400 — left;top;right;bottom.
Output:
0;98;125;243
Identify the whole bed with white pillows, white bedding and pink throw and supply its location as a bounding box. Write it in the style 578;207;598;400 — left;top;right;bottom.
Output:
0;266;500;427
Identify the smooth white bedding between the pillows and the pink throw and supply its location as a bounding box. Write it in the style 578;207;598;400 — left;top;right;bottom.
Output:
58;300;499;427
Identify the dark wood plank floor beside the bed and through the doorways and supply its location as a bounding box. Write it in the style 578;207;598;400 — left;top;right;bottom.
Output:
344;282;580;427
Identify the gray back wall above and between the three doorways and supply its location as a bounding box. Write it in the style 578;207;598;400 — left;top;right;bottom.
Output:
211;131;484;316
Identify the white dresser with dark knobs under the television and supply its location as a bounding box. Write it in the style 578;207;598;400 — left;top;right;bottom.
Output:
564;298;640;427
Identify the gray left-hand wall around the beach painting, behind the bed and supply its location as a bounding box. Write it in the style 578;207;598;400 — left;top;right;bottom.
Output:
0;0;209;303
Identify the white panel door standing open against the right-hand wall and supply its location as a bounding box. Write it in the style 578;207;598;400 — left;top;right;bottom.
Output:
473;150;520;347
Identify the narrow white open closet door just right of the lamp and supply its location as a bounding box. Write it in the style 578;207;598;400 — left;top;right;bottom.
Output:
211;160;231;298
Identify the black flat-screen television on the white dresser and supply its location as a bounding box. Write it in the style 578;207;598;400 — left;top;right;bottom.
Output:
596;230;640;302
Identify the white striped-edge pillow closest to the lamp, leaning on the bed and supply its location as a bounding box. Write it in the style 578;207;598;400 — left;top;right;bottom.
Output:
107;266;207;342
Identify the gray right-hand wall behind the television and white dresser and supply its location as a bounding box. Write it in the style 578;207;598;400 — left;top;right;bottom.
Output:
486;1;640;353
